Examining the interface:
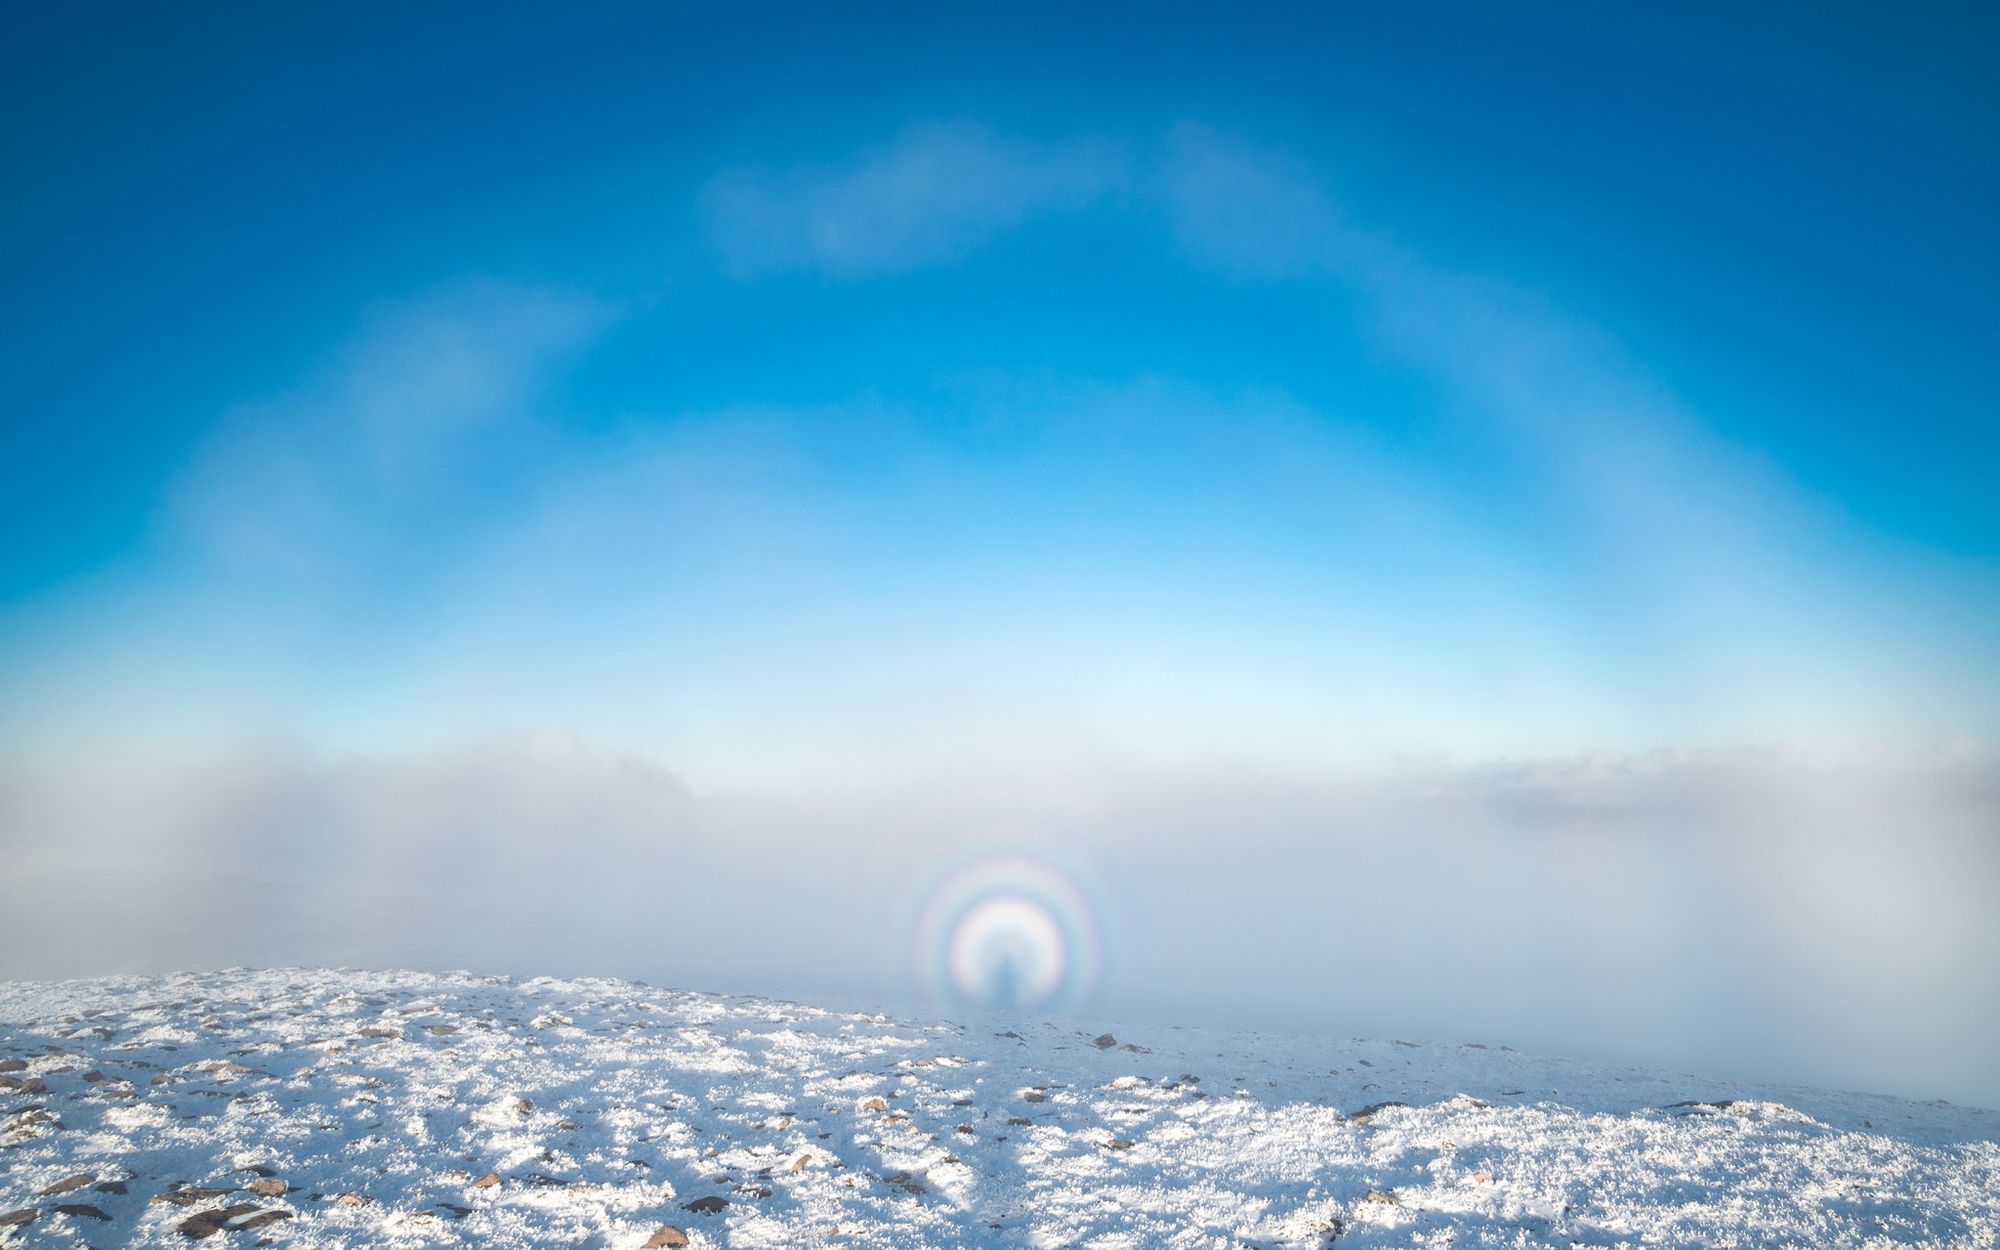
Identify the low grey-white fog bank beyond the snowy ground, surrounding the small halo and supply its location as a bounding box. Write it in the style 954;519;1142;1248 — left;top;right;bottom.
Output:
0;738;2000;1106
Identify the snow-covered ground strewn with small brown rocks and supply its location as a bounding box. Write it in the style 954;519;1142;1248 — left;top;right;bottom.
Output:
0;970;2000;1250
